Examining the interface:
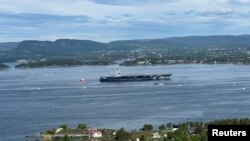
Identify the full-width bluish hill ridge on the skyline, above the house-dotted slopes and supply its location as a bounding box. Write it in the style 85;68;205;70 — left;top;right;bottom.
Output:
0;35;250;59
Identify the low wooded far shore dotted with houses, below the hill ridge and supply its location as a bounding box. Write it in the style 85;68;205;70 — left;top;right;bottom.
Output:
12;48;250;68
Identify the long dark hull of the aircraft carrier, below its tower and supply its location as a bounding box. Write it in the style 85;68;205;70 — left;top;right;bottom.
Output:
100;74;172;82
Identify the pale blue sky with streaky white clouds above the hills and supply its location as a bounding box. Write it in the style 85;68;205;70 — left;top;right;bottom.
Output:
0;0;250;42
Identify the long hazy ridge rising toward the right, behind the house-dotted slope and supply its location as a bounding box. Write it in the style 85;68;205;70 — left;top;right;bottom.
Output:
109;35;250;49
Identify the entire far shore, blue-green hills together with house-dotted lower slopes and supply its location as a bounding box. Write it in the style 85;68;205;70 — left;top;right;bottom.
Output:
0;35;250;68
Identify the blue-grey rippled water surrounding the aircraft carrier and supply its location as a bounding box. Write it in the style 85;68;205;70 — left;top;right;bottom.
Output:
0;65;250;141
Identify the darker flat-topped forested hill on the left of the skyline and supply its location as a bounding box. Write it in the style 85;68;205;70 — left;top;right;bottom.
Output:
11;39;107;56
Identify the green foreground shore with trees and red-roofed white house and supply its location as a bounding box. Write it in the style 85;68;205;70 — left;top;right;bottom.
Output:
26;118;250;141
